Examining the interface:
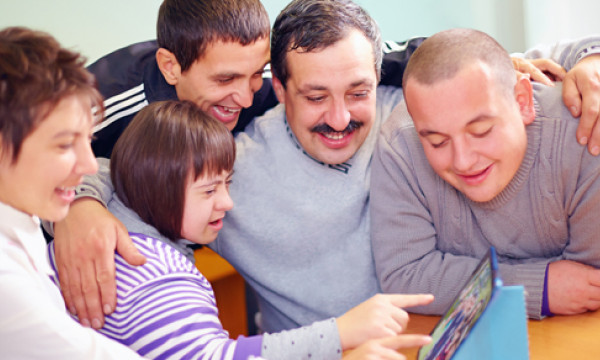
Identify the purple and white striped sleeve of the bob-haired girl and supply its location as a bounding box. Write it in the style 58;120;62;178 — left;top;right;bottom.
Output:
51;234;262;360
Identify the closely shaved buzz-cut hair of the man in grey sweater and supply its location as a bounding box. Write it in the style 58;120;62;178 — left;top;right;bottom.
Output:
402;28;516;94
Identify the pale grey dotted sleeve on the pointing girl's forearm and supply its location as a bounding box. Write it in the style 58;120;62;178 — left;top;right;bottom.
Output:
261;318;342;360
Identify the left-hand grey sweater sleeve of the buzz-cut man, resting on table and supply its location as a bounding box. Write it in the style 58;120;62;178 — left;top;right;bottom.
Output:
370;122;478;314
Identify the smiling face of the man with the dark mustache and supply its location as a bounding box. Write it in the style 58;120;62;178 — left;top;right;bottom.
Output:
273;30;377;164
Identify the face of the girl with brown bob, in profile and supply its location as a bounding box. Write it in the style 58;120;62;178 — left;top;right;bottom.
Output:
181;171;233;244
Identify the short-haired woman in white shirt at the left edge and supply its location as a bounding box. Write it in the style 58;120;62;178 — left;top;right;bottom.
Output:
0;27;144;359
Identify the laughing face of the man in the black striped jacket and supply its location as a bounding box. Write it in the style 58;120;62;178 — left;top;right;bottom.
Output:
164;38;270;130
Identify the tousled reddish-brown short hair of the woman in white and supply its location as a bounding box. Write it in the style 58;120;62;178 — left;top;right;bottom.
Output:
0;27;102;163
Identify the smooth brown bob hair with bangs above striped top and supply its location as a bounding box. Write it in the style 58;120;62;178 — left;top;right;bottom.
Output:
110;100;235;241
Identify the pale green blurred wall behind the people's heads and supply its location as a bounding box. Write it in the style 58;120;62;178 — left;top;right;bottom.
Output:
0;0;600;62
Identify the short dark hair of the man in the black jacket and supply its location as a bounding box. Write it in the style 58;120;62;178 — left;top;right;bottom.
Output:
156;0;271;71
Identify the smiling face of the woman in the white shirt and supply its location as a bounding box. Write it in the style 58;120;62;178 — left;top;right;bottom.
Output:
0;95;98;221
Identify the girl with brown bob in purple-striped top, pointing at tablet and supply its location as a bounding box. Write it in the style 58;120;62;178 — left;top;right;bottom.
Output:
50;101;424;359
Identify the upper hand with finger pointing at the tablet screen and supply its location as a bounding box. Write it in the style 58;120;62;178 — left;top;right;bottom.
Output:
337;294;433;350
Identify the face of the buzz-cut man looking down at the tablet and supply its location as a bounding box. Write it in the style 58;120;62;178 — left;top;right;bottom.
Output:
405;62;533;202
